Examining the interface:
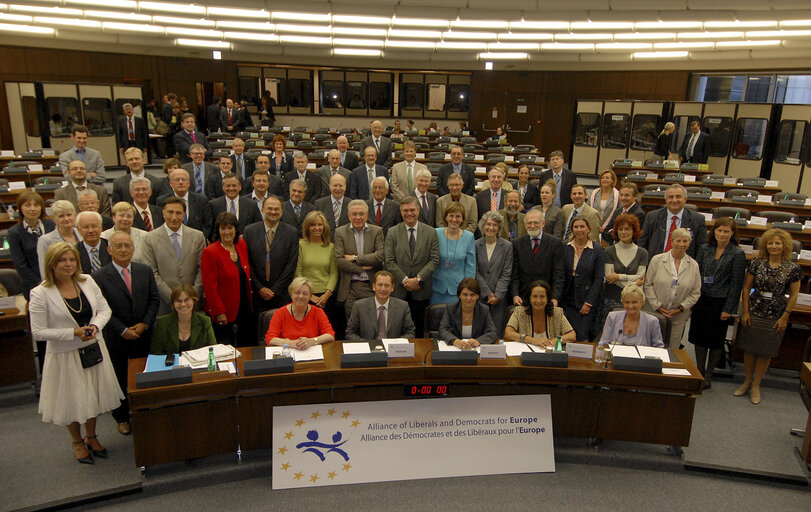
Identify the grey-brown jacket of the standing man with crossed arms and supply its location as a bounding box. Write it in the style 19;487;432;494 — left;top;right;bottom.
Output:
333;224;384;302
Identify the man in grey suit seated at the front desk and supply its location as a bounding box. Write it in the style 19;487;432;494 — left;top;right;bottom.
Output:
346;270;416;341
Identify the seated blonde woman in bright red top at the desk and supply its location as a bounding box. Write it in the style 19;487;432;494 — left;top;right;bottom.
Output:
265;277;335;350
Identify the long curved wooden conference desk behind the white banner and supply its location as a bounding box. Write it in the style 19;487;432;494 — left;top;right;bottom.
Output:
127;339;703;467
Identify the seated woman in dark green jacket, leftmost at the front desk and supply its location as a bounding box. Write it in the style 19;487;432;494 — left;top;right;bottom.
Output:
149;284;217;354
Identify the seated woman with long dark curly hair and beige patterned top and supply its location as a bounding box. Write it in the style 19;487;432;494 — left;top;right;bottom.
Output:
504;280;576;347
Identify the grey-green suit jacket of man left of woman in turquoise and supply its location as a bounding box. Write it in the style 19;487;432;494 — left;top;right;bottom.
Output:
385;222;439;300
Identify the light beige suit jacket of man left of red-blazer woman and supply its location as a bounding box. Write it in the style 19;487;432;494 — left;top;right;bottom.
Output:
144;226;206;311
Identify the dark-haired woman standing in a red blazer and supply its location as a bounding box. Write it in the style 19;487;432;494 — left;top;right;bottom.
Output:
200;212;256;347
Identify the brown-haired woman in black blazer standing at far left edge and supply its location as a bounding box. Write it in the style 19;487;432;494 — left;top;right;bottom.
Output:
8;191;55;300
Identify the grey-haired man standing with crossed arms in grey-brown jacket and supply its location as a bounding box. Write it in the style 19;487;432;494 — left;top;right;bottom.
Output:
334;199;384;318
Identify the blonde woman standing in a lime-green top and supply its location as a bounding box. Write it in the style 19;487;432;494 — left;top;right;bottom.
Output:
296;210;346;339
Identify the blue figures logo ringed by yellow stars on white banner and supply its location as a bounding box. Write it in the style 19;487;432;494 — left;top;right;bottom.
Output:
277;408;360;485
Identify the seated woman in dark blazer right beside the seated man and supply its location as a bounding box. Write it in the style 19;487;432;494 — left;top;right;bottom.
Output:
439;277;498;348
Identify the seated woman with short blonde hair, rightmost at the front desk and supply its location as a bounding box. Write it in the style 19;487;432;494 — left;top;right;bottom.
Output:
600;283;665;347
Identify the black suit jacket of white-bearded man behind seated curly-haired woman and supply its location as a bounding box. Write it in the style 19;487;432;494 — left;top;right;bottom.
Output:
510;234;565;302
